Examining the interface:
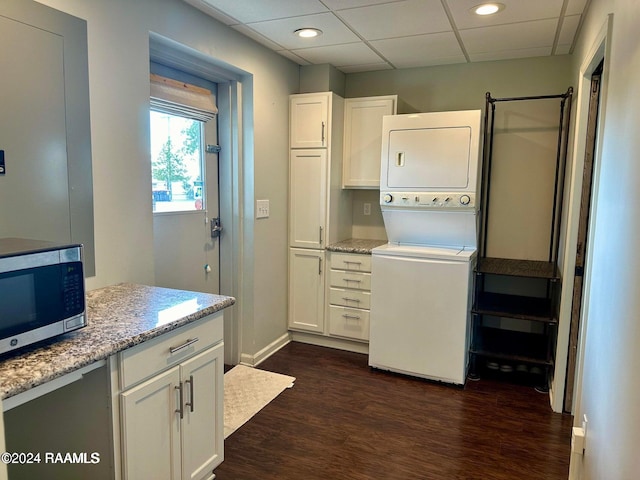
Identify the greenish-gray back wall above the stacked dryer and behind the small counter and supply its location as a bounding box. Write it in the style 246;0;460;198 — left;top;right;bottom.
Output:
342;55;573;243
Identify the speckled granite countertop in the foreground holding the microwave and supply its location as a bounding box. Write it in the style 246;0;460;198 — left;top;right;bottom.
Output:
0;283;235;399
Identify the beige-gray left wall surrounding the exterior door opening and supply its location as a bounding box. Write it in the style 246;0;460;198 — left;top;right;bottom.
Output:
41;0;299;360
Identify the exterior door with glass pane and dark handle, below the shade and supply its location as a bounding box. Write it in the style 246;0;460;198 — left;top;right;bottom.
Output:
151;113;220;293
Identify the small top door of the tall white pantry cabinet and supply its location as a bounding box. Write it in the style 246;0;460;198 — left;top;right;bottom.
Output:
289;93;329;148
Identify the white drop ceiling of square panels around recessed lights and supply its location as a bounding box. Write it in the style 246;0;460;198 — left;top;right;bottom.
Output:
184;0;590;73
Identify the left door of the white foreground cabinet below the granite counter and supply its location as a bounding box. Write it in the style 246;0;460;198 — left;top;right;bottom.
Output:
120;367;181;480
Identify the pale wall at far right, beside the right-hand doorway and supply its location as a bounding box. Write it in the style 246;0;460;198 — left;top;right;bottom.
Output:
572;0;640;480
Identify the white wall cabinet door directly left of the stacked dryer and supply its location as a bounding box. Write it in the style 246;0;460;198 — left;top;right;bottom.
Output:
342;95;396;188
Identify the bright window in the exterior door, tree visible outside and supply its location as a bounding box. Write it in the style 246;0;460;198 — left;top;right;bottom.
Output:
150;110;205;212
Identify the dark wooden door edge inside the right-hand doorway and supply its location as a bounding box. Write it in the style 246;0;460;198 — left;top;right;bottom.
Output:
563;62;604;412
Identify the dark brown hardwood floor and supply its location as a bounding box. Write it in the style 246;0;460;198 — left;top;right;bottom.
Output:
216;342;572;480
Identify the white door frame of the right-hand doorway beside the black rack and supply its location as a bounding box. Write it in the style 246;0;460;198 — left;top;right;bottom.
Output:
550;15;613;412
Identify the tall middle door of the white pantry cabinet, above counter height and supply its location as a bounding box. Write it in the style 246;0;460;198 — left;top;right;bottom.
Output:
289;149;327;248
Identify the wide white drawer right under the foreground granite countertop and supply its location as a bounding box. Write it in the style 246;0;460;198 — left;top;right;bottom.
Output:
118;312;224;390
